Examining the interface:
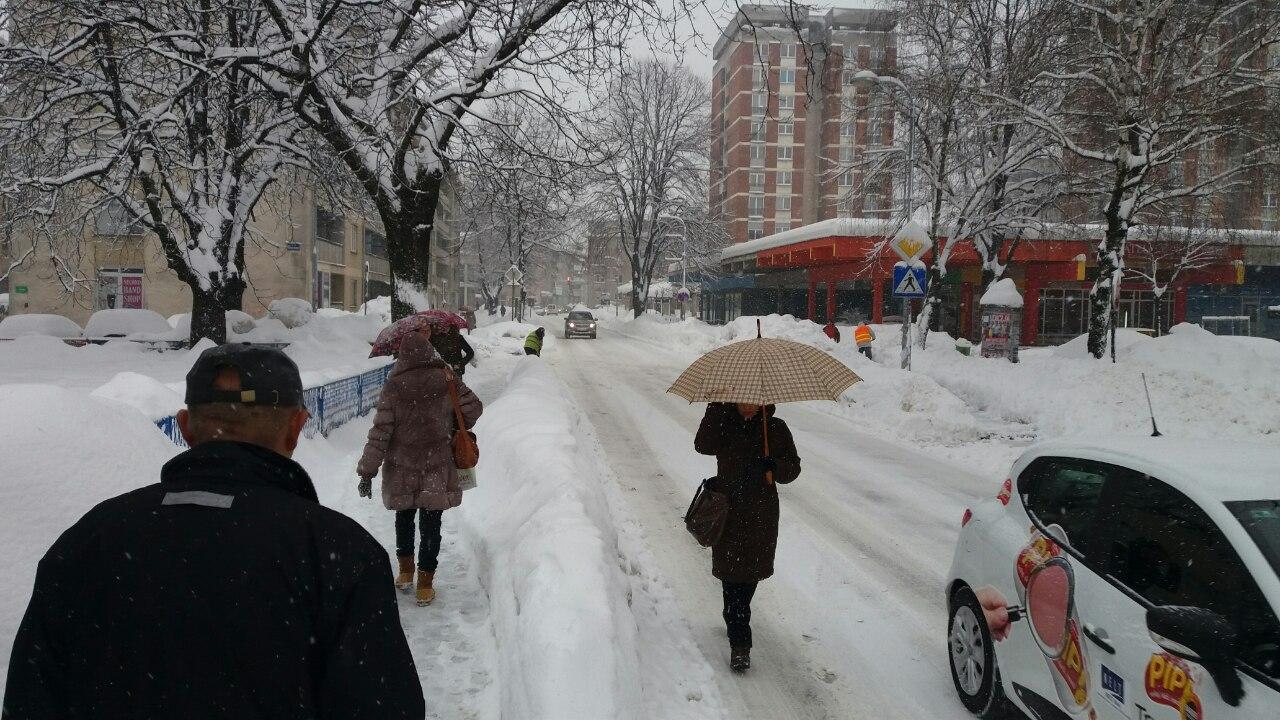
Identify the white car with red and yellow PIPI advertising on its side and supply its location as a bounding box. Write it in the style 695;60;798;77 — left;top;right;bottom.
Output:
946;437;1280;720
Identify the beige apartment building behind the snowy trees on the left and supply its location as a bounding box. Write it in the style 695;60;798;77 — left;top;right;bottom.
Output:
9;175;466;324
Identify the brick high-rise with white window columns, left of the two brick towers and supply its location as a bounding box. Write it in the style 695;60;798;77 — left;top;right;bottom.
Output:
709;5;897;242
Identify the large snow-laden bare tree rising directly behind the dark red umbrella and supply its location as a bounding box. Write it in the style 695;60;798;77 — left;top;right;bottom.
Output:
245;0;686;316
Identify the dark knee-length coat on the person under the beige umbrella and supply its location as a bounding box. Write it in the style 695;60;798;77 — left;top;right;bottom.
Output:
694;402;800;583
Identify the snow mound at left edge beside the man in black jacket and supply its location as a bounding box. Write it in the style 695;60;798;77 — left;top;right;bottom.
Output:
0;384;178;696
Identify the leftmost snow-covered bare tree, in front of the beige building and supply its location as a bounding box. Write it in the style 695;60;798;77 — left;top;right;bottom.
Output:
0;0;308;342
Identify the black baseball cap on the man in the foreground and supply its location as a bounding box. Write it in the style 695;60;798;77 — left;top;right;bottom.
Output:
187;343;303;407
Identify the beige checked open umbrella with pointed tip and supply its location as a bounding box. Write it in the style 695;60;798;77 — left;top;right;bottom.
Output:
667;338;861;405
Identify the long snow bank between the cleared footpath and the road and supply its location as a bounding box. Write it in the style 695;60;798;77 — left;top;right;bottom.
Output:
460;359;644;720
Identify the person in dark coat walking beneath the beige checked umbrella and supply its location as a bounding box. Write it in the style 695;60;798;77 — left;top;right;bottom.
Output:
694;402;800;673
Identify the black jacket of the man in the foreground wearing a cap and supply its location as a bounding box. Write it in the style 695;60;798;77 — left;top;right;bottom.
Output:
3;442;425;720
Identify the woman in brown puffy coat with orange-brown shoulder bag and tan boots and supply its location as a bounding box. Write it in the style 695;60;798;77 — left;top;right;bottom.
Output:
356;325;484;605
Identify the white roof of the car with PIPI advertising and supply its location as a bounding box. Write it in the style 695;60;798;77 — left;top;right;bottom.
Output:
1016;436;1280;502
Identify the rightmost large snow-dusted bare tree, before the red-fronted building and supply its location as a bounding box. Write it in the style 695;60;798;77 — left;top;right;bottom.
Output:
1012;0;1280;357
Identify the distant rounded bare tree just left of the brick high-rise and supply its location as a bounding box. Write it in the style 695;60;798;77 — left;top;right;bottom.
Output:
590;60;710;316
